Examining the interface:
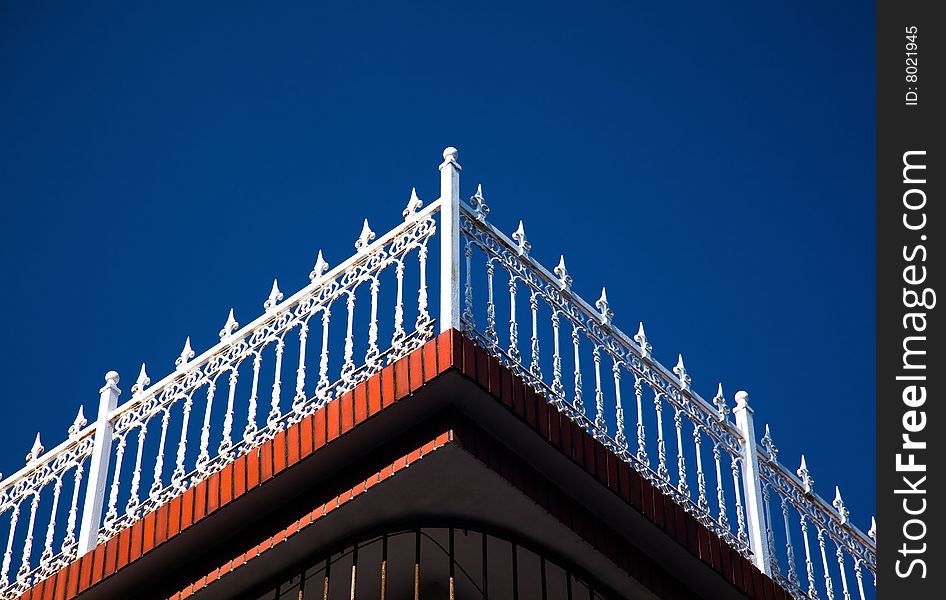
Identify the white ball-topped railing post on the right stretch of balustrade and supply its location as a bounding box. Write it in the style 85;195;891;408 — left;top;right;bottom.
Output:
733;391;772;576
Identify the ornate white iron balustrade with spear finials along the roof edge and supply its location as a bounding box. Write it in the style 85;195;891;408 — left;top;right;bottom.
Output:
0;148;876;600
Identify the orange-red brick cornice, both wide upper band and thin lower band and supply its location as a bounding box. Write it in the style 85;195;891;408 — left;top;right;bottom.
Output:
21;330;790;600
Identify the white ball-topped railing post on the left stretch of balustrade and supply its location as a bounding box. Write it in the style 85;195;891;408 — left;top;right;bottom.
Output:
76;371;122;556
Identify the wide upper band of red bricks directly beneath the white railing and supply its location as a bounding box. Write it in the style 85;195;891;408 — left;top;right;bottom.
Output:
21;330;789;600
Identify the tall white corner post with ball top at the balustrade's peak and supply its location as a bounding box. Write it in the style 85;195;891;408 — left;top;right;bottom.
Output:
440;146;461;333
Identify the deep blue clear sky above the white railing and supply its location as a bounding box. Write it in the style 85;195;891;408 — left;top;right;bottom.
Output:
0;1;875;529
